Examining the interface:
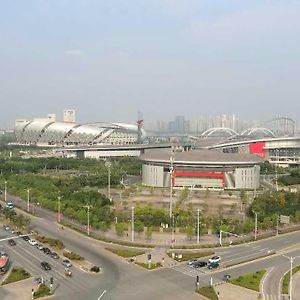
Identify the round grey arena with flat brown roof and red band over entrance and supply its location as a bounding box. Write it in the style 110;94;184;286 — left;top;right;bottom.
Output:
141;150;262;189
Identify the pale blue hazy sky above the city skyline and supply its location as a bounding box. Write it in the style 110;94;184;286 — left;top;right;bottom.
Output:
0;0;300;127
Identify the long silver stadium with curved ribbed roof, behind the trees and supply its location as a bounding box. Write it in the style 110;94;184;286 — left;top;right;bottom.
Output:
15;118;146;147
